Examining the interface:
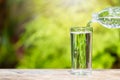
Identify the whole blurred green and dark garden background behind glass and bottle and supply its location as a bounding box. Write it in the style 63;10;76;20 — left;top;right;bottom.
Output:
0;0;120;69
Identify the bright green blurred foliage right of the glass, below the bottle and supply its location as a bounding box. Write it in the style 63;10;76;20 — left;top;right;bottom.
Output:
93;26;120;68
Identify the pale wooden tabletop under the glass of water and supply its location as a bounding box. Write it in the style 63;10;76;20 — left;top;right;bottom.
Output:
0;69;120;80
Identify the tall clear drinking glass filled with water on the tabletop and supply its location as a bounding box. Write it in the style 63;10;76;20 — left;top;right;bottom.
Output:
70;27;93;75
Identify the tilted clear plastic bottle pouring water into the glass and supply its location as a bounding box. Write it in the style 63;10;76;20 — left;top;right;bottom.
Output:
91;7;120;28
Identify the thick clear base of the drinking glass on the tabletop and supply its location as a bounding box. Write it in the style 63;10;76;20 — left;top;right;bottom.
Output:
71;69;92;75
